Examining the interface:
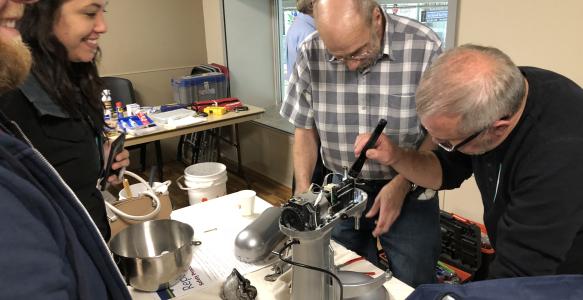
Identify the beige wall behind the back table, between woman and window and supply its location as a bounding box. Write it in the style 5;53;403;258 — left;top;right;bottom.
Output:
99;0;208;161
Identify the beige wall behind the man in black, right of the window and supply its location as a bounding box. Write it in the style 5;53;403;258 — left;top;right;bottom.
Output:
442;0;583;222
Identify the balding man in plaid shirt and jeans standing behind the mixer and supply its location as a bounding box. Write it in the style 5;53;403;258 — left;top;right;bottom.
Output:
280;0;441;286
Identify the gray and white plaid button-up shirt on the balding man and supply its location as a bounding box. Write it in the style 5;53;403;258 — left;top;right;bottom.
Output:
280;12;442;179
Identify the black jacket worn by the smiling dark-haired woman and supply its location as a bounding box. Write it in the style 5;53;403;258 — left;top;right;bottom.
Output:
0;75;110;240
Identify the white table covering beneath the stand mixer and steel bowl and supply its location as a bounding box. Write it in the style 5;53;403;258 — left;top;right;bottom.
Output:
129;193;413;300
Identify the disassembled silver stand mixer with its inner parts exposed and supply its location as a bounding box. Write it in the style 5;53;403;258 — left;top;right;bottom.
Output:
279;119;392;300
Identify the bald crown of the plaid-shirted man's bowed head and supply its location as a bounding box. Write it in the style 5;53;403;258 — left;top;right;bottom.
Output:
314;0;371;56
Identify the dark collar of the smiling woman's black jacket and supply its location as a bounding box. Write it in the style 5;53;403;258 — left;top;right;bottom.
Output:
20;74;70;118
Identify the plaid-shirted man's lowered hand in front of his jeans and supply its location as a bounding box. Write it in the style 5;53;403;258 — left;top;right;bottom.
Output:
366;176;409;237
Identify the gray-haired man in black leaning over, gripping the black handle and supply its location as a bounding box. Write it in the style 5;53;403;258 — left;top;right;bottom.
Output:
356;45;583;278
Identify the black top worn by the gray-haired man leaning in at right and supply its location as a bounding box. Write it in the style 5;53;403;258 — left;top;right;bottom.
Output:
436;67;583;278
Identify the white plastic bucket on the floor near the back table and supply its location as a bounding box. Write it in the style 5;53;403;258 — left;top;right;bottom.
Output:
177;162;227;205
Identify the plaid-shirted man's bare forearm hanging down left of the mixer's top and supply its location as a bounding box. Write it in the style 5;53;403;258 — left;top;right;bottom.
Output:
293;128;318;194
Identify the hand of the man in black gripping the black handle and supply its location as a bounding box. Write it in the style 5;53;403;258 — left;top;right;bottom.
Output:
354;133;401;166
